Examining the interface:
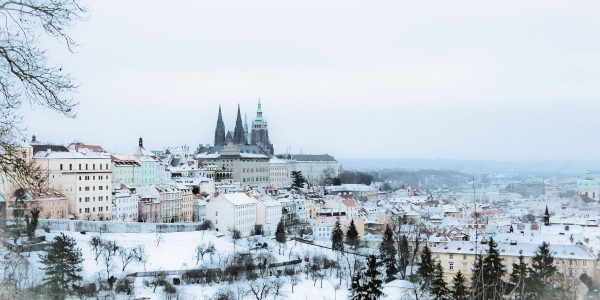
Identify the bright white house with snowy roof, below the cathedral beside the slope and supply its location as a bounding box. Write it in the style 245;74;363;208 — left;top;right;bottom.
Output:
206;193;256;237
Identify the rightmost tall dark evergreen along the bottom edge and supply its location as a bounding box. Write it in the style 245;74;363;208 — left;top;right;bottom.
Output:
526;242;559;299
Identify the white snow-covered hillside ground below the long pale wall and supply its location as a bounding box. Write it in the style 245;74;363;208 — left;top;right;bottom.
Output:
2;231;414;299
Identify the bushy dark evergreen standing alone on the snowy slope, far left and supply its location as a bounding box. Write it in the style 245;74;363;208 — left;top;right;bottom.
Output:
40;233;83;297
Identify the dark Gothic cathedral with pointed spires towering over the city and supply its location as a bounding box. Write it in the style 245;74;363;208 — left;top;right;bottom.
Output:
214;99;274;156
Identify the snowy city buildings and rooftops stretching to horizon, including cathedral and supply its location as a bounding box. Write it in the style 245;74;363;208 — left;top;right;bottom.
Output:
0;100;600;298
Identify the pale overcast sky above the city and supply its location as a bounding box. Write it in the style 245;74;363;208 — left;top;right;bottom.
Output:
24;0;600;160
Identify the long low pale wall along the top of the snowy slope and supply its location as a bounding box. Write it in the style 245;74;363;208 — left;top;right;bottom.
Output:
38;219;201;233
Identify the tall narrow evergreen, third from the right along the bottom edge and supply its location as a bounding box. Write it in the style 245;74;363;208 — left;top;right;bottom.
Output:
482;237;506;300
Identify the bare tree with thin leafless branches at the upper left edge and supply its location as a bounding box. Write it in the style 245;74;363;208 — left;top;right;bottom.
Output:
0;0;85;188
